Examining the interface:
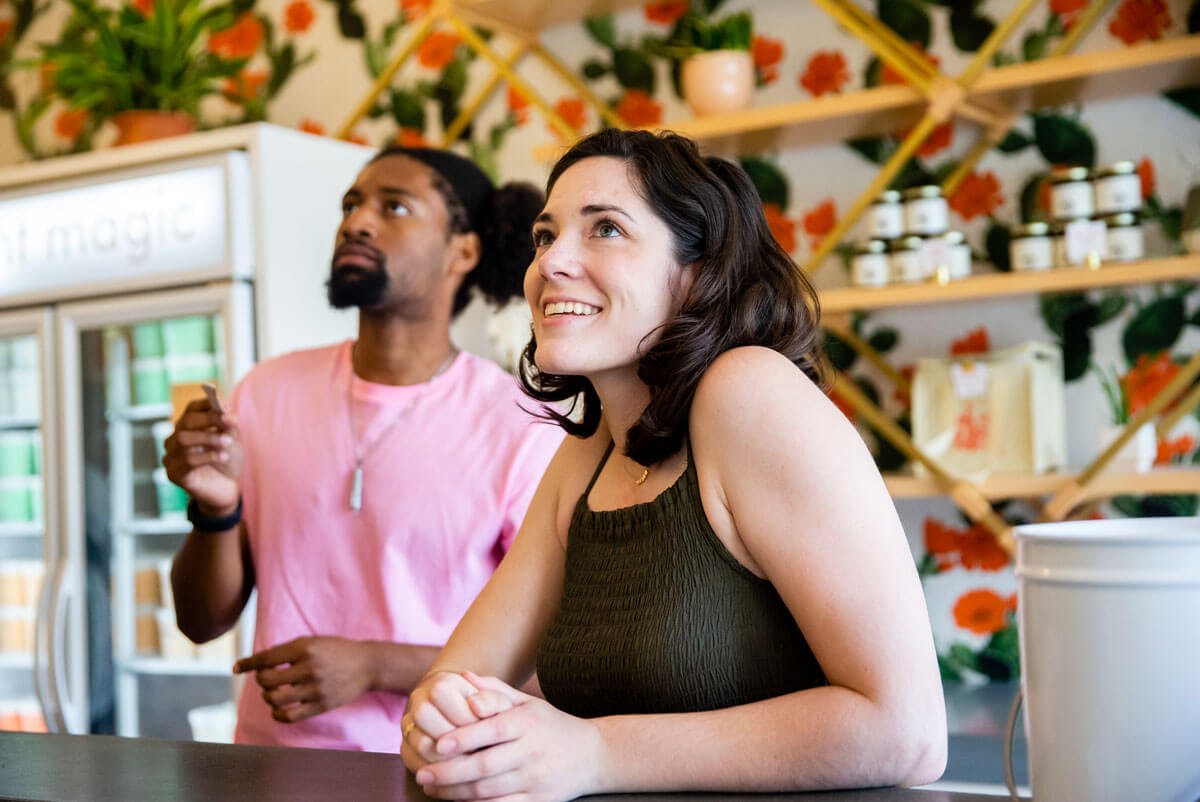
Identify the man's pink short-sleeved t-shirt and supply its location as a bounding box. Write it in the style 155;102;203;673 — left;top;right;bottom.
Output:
230;342;563;752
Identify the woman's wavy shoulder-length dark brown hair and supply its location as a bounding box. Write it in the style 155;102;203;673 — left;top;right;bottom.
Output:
521;128;824;466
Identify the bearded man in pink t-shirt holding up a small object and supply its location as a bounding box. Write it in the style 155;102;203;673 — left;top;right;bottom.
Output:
163;146;562;752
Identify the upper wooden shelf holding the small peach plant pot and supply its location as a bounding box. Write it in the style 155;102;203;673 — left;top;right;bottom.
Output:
534;34;1200;162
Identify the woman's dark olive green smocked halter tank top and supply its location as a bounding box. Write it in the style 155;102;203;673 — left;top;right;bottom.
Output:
538;444;826;718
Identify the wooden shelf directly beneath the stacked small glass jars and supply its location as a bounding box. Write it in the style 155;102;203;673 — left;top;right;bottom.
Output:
817;255;1200;315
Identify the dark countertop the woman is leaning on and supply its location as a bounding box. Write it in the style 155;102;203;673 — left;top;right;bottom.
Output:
0;732;1017;802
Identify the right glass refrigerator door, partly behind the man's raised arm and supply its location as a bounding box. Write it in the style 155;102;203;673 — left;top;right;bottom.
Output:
61;285;252;740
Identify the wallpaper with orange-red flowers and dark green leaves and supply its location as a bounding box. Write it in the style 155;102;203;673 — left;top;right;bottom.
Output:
0;0;1200;680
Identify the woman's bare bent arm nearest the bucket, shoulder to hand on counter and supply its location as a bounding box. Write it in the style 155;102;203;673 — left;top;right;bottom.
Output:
418;348;947;802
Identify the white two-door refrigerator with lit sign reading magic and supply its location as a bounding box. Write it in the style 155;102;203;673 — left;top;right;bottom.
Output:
0;125;372;738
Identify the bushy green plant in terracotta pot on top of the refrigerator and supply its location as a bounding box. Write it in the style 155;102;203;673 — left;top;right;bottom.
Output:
24;0;254;144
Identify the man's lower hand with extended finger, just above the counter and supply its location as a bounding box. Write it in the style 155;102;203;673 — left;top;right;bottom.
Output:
233;635;377;724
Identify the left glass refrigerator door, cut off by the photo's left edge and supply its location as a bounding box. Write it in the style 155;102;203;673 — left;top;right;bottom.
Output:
0;312;56;732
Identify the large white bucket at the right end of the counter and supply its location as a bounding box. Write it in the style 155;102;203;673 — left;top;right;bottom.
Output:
1015;517;1200;802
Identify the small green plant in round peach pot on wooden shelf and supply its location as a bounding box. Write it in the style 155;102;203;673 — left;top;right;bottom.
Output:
658;0;755;116
